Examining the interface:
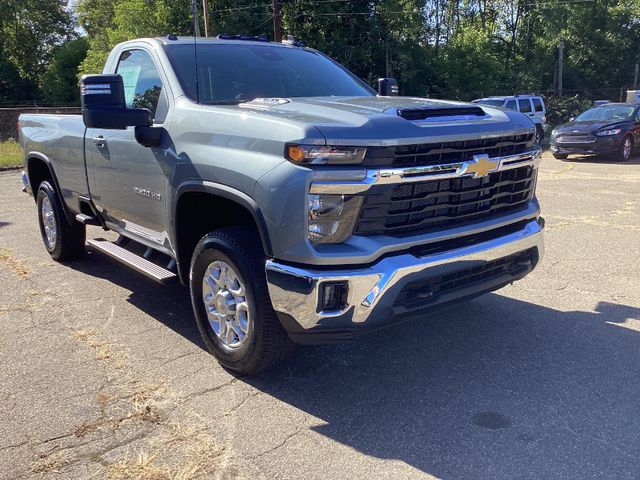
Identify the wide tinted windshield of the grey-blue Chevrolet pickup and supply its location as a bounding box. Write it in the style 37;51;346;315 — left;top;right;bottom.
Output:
165;44;375;104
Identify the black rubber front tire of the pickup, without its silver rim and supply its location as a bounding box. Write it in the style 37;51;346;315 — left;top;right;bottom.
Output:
189;227;293;375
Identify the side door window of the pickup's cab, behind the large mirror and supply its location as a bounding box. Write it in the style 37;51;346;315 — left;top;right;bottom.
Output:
116;50;167;123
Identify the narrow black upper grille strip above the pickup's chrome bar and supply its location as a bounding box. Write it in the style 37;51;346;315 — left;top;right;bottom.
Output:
364;133;533;167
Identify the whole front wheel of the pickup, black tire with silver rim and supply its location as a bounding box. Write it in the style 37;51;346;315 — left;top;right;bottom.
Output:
190;227;293;375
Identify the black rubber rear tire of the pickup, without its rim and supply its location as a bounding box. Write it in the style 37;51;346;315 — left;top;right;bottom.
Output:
36;180;86;261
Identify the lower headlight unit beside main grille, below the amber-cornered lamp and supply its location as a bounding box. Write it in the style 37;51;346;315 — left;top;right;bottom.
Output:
308;194;362;243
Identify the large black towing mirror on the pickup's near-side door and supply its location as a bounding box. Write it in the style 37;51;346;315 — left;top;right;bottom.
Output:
80;75;153;130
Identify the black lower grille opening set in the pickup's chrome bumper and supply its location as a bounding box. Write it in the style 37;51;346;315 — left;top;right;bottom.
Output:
394;248;538;310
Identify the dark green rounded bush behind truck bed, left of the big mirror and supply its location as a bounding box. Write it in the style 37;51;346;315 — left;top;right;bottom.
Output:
42;38;89;104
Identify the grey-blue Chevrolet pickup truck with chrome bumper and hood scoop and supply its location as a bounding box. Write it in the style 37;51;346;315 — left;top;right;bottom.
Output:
19;35;544;374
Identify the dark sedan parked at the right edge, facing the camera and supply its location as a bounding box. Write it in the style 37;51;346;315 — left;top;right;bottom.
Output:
551;103;640;161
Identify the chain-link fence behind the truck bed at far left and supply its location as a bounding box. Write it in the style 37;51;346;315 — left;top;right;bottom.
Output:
0;104;80;170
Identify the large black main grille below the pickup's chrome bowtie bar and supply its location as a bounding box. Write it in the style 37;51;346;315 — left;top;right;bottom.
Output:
354;166;536;236
